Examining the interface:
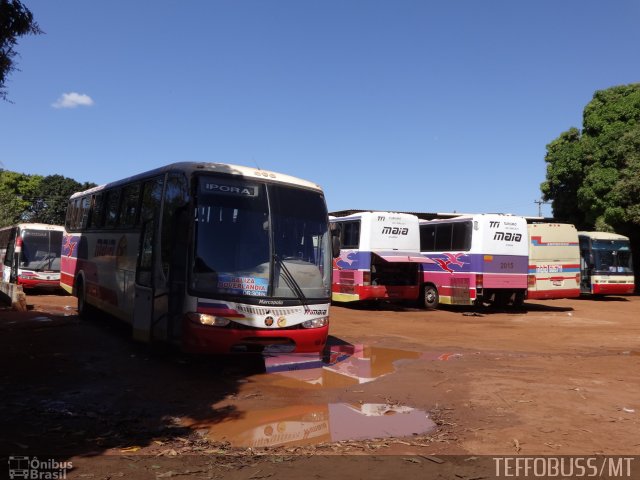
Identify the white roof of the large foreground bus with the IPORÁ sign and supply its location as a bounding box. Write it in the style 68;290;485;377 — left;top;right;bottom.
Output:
71;162;322;198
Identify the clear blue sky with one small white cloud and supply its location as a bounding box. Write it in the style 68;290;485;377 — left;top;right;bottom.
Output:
0;0;640;216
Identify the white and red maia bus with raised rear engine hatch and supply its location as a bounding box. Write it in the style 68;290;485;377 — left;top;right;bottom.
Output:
330;212;429;302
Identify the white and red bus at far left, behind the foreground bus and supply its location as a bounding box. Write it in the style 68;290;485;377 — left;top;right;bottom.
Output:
0;223;64;289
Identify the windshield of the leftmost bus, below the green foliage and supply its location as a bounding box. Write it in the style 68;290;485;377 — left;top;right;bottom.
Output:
20;230;62;272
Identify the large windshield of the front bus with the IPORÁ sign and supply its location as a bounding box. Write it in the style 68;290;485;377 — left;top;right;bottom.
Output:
191;176;331;300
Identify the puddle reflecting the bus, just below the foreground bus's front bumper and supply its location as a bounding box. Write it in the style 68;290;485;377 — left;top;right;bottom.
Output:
264;345;462;388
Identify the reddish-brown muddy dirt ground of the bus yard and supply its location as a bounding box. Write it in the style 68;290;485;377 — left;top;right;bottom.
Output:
0;294;640;479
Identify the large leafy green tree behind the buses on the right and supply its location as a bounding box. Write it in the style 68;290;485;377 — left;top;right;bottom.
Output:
540;83;640;283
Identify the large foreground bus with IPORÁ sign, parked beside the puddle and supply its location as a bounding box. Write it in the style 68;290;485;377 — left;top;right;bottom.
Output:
61;163;332;353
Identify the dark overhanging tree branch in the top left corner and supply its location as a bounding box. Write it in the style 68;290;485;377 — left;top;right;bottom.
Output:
0;0;43;100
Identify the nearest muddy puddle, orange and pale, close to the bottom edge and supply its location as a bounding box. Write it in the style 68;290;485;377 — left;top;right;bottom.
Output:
183;403;436;447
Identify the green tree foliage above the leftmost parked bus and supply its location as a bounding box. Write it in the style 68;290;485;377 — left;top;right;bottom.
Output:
0;170;95;227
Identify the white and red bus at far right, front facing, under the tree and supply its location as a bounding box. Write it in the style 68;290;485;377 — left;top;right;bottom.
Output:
578;232;635;295
